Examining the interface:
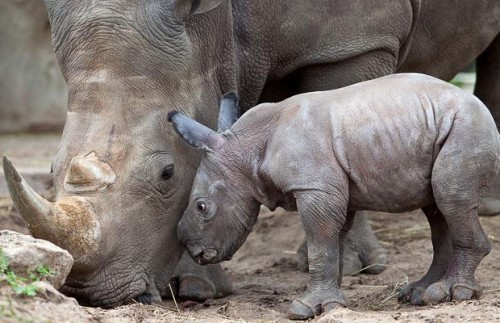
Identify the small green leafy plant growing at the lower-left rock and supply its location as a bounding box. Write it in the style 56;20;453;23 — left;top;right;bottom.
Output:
0;248;55;296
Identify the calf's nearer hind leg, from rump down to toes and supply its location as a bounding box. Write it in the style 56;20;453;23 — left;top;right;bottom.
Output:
422;122;499;304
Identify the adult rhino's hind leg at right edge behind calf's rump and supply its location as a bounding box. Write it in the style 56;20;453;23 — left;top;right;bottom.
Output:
474;34;500;215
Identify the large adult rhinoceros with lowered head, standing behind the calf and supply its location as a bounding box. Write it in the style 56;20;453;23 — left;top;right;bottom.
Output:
4;0;500;307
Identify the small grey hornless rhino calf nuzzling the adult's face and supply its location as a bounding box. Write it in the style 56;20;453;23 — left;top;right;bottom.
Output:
170;74;500;319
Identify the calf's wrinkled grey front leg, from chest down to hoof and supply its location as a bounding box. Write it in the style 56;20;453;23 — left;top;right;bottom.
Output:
289;191;354;320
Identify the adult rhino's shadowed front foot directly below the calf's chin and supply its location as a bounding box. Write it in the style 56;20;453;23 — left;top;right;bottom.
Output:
167;252;233;301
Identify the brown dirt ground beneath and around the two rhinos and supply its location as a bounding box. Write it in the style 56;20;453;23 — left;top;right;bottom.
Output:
0;198;500;322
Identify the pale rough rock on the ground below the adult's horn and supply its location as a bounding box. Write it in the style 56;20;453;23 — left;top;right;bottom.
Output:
0;230;73;288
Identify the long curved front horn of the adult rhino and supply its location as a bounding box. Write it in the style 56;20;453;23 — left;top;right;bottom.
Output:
3;156;101;264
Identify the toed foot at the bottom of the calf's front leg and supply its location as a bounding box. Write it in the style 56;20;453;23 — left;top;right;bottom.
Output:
288;289;347;320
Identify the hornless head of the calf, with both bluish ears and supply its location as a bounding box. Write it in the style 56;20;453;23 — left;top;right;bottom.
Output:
169;95;260;265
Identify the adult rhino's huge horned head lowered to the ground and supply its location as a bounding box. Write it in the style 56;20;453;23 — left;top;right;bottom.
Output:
4;0;240;307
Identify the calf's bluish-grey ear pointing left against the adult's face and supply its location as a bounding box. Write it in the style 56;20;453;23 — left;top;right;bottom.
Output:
168;111;226;152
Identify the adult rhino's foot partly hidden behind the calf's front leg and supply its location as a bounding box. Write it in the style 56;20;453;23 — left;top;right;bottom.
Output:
297;211;387;276
